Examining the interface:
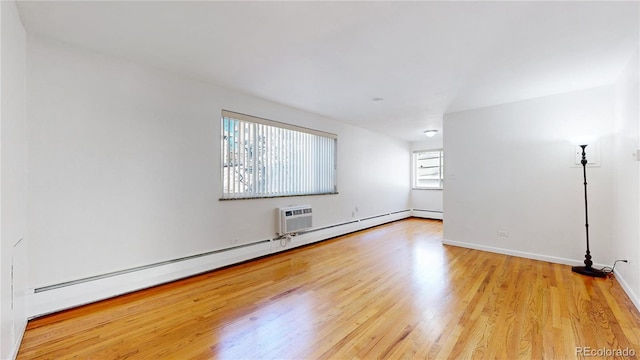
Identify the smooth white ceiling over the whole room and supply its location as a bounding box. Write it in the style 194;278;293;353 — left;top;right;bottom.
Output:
19;1;640;141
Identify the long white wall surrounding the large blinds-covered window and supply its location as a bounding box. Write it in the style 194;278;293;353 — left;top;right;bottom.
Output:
27;38;410;315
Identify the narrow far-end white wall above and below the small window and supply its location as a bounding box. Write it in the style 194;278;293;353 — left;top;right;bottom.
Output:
411;137;447;219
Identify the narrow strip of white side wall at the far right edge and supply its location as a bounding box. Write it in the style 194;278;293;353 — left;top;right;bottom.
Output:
612;46;640;308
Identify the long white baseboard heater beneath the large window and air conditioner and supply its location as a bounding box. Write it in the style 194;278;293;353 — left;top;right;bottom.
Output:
27;210;411;320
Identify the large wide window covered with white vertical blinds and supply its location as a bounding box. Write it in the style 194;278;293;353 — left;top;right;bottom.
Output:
222;110;338;199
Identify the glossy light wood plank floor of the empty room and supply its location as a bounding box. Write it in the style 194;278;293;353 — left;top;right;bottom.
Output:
18;219;640;359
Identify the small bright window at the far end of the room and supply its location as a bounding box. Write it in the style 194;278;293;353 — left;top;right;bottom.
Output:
413;149;444;189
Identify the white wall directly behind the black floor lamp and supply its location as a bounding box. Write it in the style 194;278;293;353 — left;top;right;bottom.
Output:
444;86;614;265
